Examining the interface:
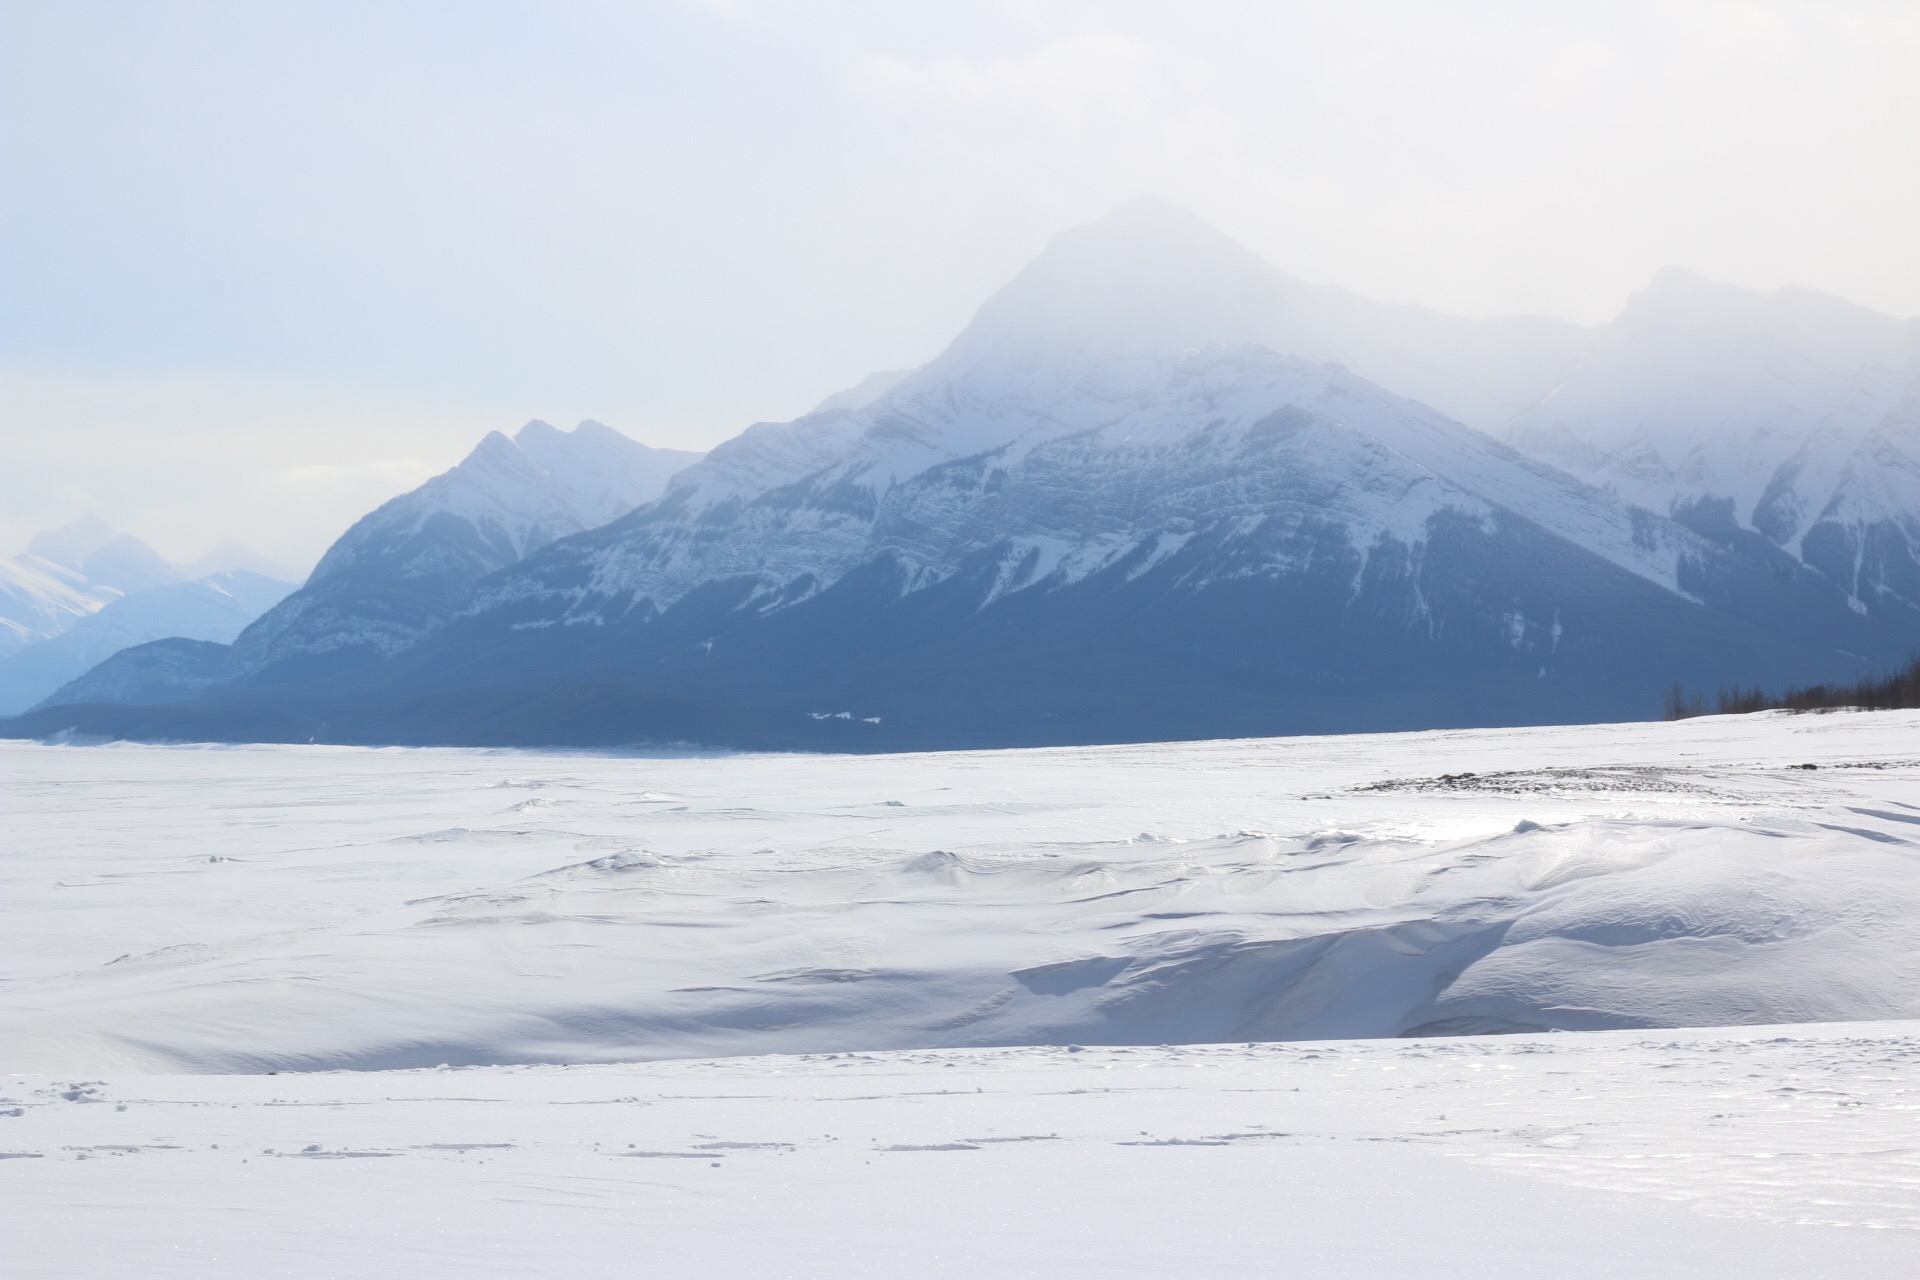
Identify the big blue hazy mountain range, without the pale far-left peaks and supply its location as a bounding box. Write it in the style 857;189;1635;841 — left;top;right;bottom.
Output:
12;201;1920;750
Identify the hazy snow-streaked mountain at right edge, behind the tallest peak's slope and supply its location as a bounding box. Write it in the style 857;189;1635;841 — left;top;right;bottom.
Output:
1503;271;1920;620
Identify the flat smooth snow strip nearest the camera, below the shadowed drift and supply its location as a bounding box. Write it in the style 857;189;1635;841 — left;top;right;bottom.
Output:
0;1023;1920;1280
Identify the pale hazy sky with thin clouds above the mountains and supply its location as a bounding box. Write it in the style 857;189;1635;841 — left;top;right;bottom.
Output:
0;0;1920;568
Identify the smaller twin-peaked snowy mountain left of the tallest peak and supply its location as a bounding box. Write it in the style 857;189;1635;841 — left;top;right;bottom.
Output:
232;422;701;677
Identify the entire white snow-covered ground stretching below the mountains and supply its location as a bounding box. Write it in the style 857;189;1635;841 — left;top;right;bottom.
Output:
0;712;1920;1276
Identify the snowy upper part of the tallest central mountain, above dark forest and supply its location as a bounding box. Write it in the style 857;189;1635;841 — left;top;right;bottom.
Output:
453;201;1620;629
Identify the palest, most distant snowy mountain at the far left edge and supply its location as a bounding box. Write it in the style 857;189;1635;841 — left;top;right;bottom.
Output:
0;516;188;658
